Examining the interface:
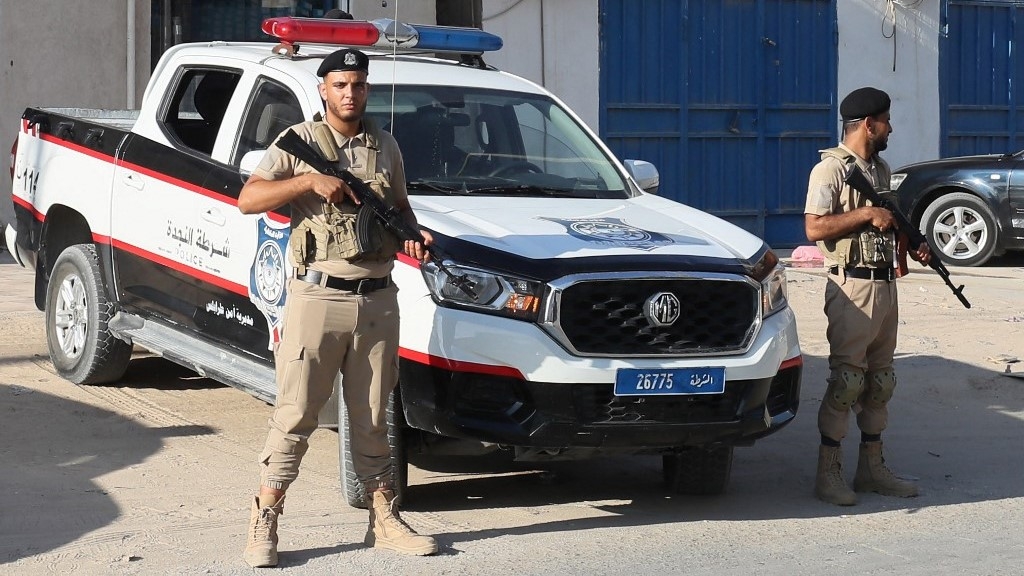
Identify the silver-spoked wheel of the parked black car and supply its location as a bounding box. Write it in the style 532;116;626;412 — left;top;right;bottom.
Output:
921;192;998;266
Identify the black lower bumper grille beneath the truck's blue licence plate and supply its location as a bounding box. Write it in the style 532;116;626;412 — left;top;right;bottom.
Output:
572;384;742;424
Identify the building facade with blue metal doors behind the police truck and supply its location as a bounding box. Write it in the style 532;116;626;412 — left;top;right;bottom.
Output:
0;0;1024;247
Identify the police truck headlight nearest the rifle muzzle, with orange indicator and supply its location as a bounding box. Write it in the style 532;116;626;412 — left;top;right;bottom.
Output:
420;262;544;322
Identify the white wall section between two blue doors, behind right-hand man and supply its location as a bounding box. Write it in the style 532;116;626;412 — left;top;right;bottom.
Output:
836;0;941;168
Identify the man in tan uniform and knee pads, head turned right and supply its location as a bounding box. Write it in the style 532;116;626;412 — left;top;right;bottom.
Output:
804;87;931;506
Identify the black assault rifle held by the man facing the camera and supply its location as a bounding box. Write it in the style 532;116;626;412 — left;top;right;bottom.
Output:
278;130;476;300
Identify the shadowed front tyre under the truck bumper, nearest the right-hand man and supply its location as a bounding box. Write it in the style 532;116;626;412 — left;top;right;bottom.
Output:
662;446;732;496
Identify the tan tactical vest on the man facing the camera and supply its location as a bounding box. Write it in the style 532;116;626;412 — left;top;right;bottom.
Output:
289;118;402;274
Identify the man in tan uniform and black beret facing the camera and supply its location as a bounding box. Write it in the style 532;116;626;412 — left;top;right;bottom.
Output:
239;48;437;567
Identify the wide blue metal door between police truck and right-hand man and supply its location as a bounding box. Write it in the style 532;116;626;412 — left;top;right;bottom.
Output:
600;0;838;247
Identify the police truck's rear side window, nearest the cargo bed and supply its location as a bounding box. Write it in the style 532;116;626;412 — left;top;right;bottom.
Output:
160;69;242;156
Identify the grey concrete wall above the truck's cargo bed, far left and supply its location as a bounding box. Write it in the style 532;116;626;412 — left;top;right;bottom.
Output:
0;0;151;228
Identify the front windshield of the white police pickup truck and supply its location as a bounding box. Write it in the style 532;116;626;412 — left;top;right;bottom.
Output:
367;86;635;199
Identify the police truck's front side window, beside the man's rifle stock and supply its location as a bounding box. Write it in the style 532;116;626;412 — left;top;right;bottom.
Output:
231;78;304;166
